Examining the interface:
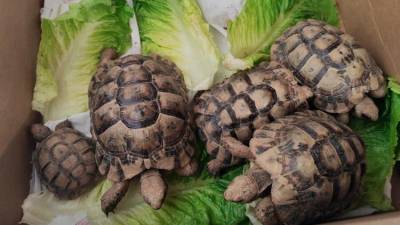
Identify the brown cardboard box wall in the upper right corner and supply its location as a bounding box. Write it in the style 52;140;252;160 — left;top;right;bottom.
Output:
337;0;400;81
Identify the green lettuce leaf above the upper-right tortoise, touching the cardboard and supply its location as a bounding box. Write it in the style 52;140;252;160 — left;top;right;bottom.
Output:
224;0;339;69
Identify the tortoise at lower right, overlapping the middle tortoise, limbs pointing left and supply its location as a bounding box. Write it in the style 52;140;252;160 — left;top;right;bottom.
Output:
224;110;365;225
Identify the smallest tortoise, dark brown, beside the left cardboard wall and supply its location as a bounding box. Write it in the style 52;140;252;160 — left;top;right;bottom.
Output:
31;120;98;199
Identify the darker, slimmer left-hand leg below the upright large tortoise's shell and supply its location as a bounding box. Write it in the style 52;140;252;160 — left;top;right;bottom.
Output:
101;180;130;215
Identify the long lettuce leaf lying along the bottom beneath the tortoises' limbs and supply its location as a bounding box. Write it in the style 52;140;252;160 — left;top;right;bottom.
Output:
22;144;247;225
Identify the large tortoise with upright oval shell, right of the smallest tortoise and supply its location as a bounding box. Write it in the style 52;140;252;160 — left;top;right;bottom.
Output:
89;49;198;214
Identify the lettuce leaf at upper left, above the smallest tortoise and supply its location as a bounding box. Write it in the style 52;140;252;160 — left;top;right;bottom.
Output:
32;0;132;121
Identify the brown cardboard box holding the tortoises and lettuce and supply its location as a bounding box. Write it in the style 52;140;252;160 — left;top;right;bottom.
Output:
0;0;400;225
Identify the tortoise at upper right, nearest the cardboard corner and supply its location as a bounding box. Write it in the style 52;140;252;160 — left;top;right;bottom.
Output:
271;19;386;123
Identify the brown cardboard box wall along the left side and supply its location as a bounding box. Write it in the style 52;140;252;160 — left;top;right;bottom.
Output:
0;0;40;225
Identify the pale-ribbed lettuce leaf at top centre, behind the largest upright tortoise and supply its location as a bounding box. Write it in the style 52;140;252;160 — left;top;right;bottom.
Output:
134;0;220;91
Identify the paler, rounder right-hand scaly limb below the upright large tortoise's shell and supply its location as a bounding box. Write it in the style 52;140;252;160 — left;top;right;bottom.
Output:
140;169;167;209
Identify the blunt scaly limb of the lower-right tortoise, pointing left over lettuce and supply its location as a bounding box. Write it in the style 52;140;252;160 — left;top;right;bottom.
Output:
224;165;272;202
